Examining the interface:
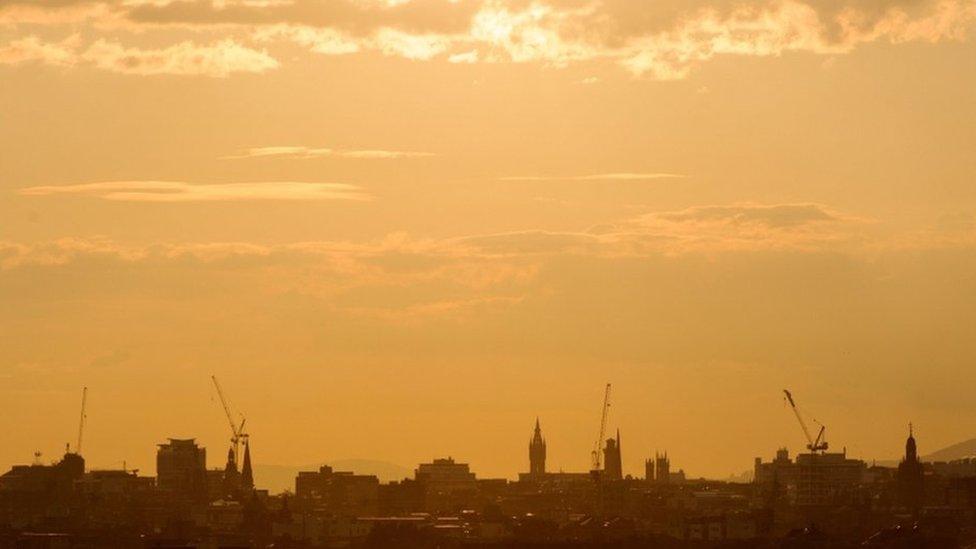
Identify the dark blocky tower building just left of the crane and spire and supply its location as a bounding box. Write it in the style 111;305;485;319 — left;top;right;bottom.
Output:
156;438;207;499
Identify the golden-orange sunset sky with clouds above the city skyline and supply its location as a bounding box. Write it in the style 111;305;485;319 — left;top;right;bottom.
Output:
0;0;976;485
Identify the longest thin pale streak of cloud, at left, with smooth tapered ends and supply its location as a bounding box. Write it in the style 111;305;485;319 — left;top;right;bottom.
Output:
20;181;370;202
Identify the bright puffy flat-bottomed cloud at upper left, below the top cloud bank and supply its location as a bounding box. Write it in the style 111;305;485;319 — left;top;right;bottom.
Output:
82;39;278;78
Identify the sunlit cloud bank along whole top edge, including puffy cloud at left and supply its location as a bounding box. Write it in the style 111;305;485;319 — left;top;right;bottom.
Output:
0;0;976;80
